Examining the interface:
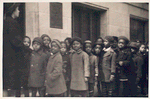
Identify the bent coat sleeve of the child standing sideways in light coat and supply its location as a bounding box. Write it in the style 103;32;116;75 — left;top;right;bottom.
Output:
49;59;63;80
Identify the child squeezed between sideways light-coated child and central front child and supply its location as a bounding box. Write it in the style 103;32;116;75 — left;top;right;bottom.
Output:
60;42;71;96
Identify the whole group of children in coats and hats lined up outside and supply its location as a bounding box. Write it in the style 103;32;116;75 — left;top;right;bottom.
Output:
18;34;148;97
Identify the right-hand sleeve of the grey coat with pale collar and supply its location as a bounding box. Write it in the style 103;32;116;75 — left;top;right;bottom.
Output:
111;52;117;75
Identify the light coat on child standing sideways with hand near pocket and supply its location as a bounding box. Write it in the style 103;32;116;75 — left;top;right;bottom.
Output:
45;52;67;94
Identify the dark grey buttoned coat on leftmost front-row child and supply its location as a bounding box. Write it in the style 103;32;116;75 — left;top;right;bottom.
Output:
28;50;48;87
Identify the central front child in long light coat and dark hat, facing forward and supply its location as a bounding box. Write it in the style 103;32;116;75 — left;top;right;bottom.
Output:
70;37;90;97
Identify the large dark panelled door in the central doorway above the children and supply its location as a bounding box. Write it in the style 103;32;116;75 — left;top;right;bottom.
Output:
72;3;100;42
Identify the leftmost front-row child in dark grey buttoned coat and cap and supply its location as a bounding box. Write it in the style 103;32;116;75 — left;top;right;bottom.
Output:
28;37;47;97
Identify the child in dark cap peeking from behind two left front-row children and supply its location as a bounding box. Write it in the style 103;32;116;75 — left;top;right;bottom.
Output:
41;34;51;55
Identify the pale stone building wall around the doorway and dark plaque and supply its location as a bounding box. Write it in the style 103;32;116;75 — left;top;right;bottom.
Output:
26;2;149;40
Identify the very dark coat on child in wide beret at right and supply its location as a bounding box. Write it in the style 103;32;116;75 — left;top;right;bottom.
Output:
116;48;134;80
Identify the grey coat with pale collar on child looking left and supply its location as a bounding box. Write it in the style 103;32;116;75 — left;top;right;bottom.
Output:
100;47;116;82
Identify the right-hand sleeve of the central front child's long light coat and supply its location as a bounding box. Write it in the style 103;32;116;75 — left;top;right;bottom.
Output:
83;53;90;77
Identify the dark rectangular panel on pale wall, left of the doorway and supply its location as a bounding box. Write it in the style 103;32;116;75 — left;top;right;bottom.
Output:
50;2;63;29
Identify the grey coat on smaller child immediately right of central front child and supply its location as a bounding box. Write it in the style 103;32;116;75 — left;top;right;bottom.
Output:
89;53;98;84
